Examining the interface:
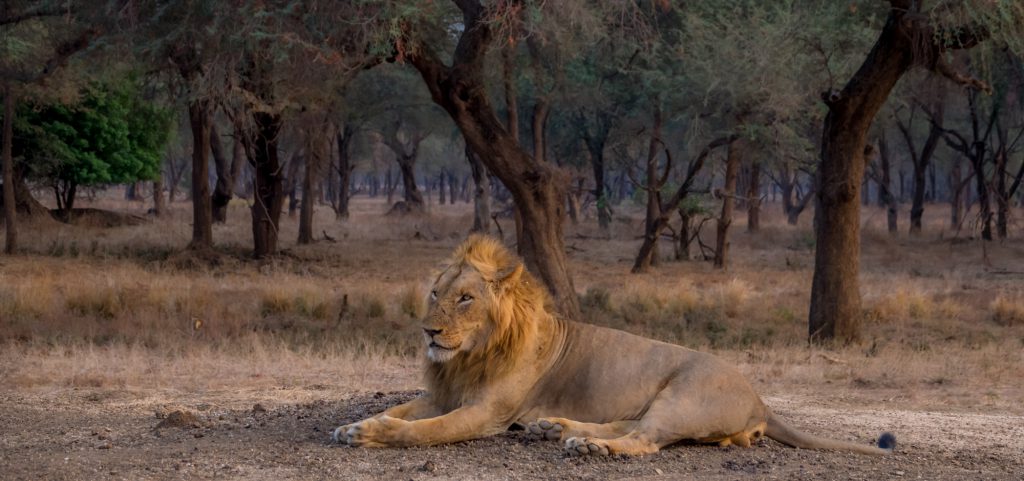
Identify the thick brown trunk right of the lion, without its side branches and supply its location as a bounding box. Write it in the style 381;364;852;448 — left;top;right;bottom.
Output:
808;3;912;343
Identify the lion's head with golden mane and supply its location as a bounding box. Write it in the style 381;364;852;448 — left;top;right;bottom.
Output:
422;235;550;407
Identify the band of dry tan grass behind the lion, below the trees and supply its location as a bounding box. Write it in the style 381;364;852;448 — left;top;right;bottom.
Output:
0;192;1024;413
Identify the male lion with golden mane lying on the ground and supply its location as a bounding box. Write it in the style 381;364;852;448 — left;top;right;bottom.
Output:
333;235;895;455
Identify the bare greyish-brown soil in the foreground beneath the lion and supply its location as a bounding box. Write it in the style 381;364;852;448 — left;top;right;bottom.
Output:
0;385;1024;480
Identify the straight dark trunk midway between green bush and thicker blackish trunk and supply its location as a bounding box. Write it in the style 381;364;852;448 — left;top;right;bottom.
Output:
188;100;213;250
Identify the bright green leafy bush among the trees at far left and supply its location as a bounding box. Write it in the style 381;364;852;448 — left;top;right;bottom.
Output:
15;79;171;185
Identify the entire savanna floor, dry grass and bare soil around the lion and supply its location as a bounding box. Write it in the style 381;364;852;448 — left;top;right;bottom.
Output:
0;193;1024;480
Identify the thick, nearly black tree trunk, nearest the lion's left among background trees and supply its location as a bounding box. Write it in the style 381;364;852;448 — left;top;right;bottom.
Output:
249;112;285;259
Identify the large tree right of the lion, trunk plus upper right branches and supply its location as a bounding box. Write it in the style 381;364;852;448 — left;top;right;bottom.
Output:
808;0;1022;342
